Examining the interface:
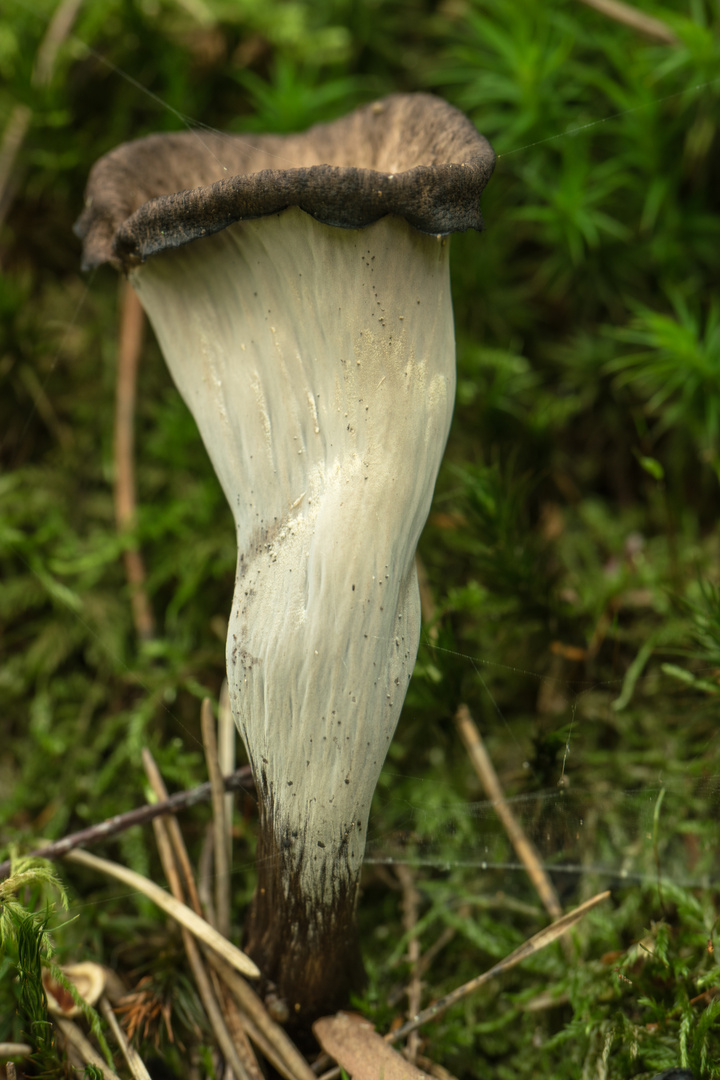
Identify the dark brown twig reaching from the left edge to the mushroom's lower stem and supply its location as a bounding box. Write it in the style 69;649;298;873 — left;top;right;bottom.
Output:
0;765;254;881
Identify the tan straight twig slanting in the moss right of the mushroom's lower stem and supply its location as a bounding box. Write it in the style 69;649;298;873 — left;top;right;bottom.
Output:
454;705;562;919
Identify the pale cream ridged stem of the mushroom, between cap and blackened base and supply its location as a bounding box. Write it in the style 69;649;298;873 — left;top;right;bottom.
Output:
132;208;454;906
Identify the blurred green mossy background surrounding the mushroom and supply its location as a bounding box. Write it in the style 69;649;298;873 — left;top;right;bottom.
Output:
0;0;720;1080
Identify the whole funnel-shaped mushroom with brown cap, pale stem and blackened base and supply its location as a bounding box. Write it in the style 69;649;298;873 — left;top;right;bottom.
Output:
76;94;494;1027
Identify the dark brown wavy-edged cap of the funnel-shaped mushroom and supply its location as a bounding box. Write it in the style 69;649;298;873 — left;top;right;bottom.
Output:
74;94;494;269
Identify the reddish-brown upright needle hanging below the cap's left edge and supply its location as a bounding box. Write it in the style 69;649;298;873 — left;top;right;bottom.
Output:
114;282;155;642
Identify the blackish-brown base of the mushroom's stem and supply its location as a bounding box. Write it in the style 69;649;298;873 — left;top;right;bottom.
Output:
244;808;365;1040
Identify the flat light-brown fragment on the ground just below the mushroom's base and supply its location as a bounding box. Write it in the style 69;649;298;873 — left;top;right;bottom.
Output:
313;1013;431;1080
